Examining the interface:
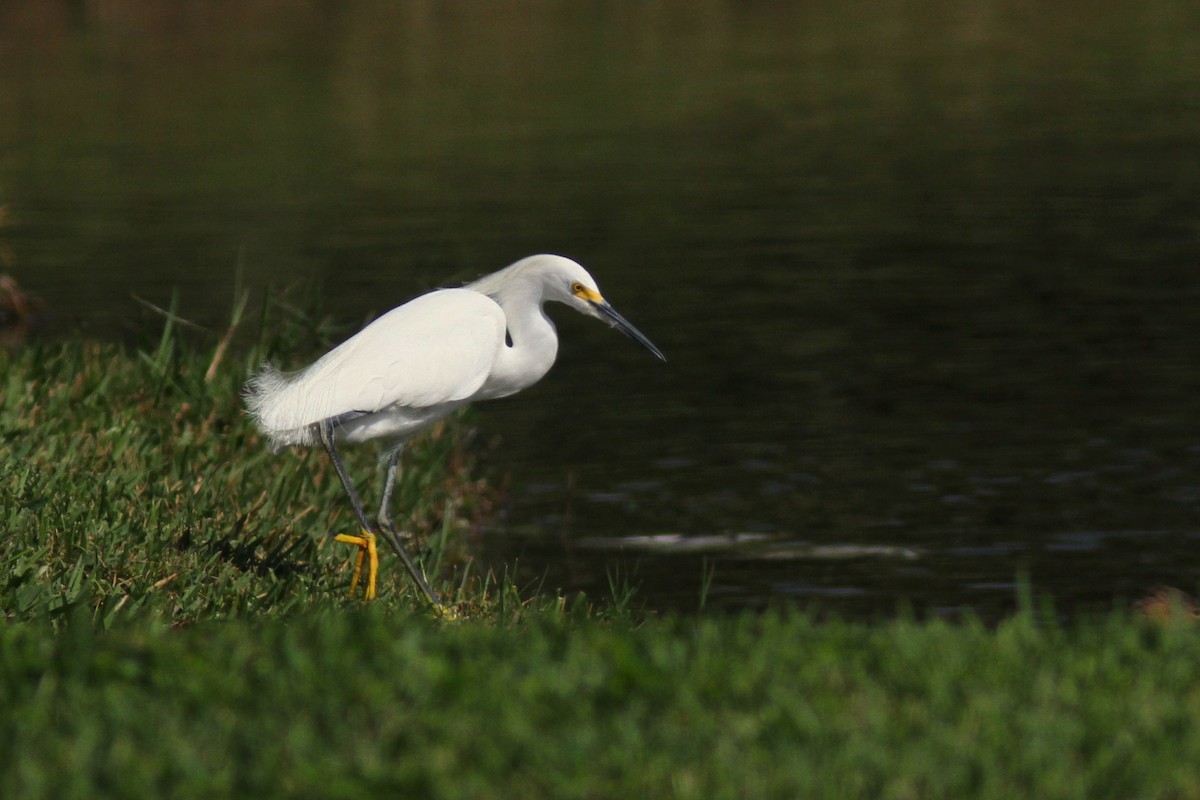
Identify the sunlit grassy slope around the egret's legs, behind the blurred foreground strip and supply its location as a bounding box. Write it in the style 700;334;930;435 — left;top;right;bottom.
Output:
0;319;487;627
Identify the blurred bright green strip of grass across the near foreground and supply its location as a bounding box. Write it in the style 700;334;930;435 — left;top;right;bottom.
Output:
0;607;1200;800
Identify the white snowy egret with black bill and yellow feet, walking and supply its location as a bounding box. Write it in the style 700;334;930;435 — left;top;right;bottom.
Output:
245;255;666;607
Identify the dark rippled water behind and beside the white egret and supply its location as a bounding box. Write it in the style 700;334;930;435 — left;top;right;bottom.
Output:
0;0;1200;615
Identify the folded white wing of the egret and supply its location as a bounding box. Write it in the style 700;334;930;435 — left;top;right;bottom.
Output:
252;289;505;431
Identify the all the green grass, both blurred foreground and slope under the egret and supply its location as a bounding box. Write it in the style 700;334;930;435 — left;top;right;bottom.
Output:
0;303;1200;799
